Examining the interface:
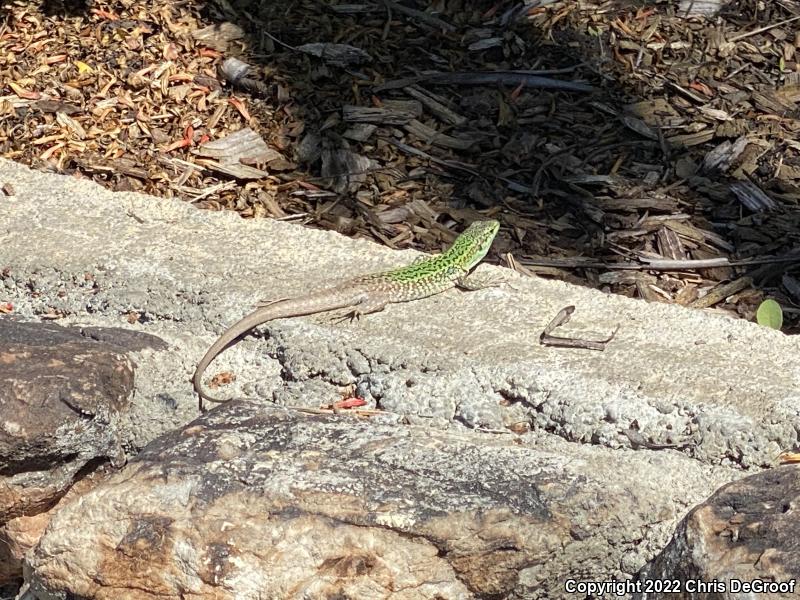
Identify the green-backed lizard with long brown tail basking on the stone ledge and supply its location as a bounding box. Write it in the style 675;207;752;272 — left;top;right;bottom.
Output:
192;221;500;412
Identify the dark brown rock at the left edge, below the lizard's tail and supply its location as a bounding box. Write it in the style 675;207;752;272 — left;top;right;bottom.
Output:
0;318;133;583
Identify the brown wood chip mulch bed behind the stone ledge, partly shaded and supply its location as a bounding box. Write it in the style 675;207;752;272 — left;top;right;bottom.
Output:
0;0;800;332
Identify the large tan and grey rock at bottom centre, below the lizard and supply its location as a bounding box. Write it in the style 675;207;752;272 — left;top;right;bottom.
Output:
28;402;732;600
